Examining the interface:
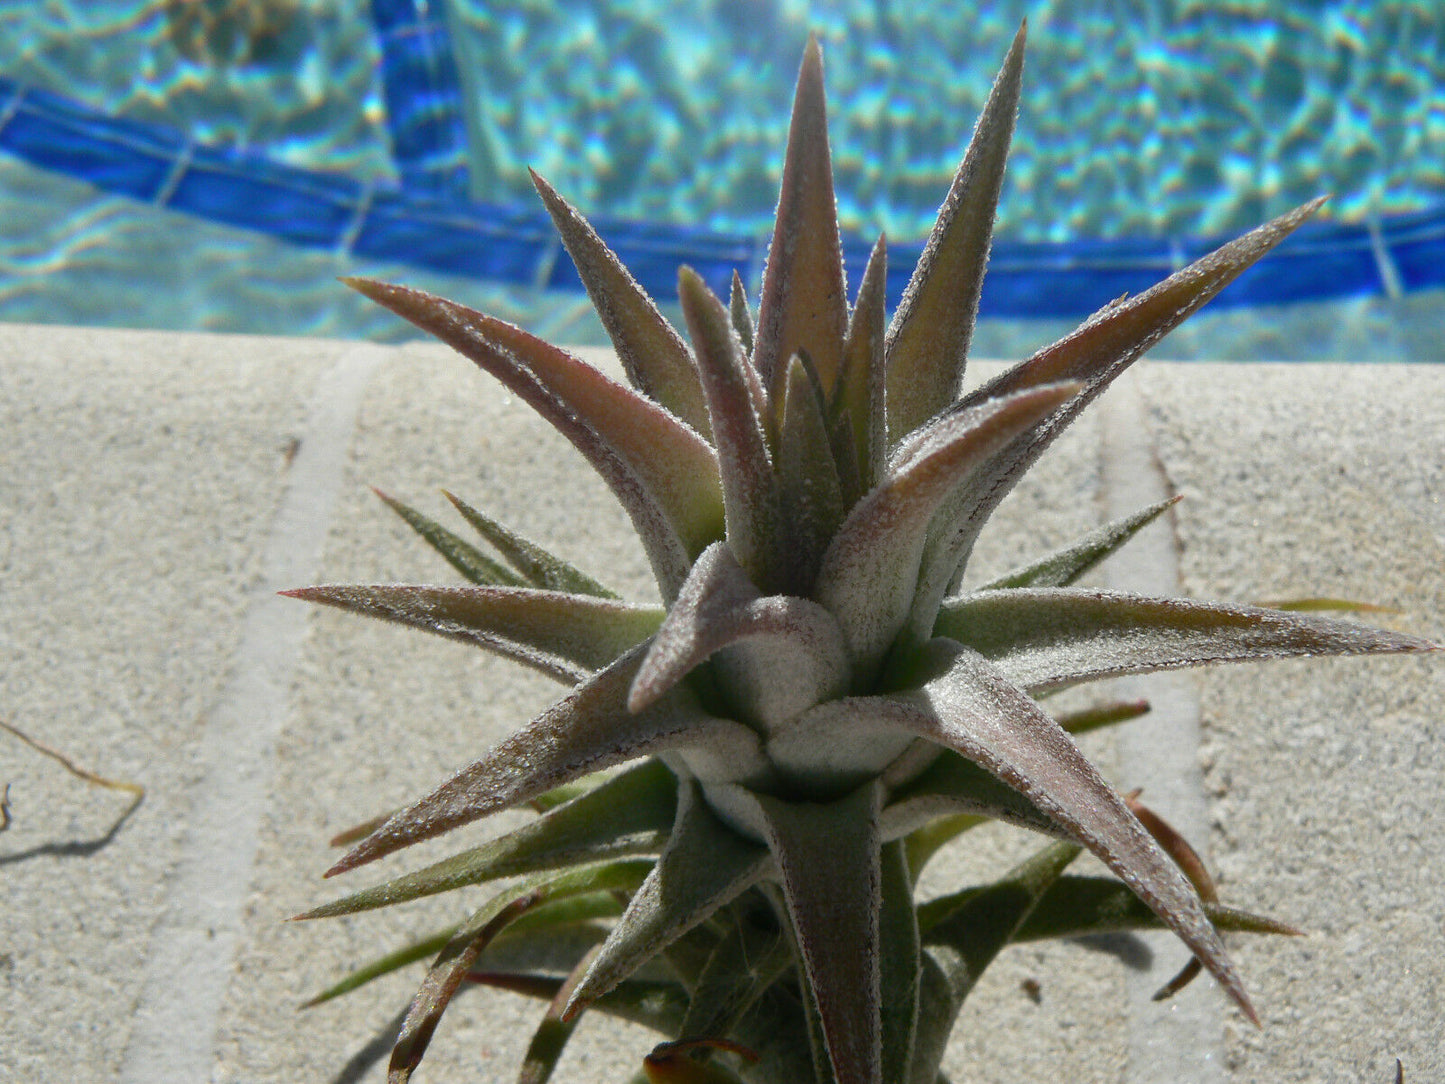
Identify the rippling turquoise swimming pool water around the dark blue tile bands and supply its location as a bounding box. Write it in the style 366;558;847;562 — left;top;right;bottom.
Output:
0;0;1445;358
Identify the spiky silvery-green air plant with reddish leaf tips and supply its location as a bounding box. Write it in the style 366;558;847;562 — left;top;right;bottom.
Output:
290;29;1433;1084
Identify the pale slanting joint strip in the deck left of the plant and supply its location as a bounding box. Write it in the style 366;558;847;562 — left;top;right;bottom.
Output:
120;345;386;1084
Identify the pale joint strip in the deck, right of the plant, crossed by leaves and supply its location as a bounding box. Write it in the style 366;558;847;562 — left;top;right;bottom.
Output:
1098;363;1227;1084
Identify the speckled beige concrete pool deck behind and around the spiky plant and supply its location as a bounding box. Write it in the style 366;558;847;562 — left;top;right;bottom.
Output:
0;325;1445;1084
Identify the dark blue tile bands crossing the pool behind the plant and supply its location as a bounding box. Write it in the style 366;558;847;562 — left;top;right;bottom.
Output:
0;66;1445;318
